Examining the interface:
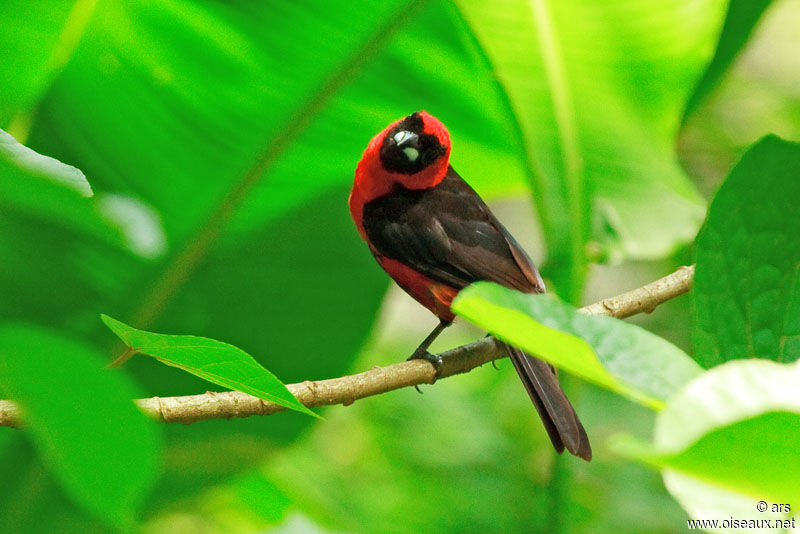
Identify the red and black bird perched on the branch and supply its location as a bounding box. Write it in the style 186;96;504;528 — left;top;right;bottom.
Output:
349;111;592;461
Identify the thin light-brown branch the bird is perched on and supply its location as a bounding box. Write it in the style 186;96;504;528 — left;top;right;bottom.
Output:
0;266;694;427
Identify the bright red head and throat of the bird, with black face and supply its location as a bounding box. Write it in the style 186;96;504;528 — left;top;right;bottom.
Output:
350;111;450;236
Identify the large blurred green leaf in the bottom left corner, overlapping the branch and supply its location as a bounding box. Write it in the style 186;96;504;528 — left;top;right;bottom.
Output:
0;325;159;528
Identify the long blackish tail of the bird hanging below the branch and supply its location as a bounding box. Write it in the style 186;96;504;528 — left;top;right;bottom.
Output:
506;345;592;462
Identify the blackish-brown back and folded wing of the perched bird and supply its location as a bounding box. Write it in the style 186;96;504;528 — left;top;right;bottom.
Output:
363;167;544;293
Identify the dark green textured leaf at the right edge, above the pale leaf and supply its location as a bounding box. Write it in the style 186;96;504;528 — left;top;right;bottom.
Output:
693;136;800;367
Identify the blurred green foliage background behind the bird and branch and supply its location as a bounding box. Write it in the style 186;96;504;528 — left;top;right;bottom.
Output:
0;0;800;533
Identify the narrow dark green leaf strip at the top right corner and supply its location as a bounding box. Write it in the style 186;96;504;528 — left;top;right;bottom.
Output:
683;0;772;121
